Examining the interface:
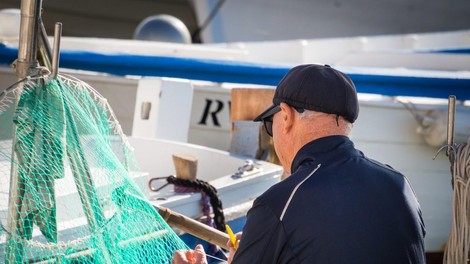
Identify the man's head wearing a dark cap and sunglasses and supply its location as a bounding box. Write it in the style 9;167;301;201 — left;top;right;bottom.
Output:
254;64;359;172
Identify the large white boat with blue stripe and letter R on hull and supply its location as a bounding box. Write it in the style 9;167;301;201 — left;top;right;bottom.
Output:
0;3;470;262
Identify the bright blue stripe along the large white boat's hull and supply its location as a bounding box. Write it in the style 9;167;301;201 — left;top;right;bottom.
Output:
0;44;470;100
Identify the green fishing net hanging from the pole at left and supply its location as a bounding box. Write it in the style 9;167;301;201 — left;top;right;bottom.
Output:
0;75;187;263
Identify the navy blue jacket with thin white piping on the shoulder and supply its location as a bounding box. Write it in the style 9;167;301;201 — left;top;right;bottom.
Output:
233;136;425;264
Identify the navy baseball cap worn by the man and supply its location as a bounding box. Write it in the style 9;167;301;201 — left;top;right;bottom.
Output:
254;64;359;123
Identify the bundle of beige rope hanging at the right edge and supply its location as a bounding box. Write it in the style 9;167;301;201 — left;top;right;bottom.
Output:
444;139;470;264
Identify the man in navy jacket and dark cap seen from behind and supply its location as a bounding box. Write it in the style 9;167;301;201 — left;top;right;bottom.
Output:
173;65;425;264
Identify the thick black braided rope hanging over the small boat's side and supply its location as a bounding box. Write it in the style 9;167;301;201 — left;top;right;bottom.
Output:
166;175;225;232
